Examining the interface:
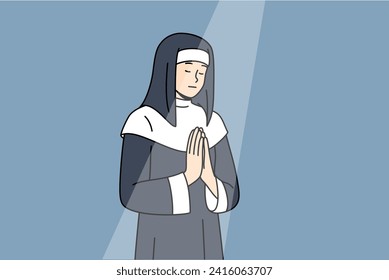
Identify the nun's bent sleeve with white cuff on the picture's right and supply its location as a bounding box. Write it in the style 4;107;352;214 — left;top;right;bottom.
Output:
206;136;239;213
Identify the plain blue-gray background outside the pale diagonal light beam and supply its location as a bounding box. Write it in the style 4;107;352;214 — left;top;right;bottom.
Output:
0;2;389;259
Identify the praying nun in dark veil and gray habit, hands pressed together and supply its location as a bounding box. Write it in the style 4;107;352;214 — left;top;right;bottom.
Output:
120;33;239;259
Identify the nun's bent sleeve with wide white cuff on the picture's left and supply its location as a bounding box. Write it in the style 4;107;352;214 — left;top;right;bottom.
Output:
120;134;190;215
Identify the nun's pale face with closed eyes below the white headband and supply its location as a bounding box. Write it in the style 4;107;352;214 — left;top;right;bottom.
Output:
176;61;207;98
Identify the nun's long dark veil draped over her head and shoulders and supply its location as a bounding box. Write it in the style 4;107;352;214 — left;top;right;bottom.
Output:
141;33;215;126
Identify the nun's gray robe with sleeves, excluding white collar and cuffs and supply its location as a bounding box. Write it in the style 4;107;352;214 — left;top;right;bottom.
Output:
120;134;239;259
